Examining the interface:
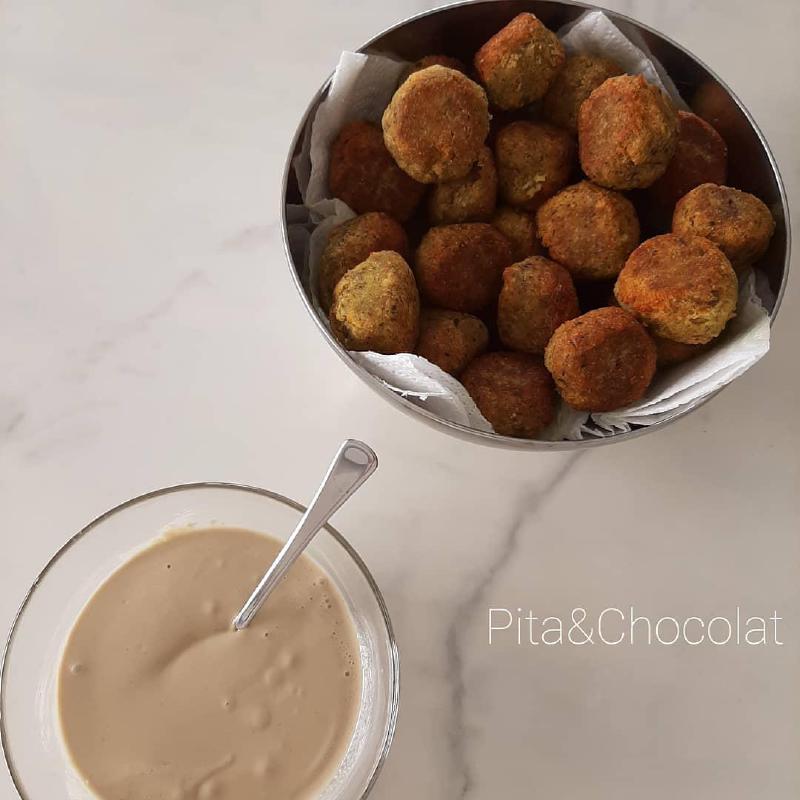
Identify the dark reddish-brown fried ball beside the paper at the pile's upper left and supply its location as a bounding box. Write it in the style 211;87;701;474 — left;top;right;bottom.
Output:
328;121;425;222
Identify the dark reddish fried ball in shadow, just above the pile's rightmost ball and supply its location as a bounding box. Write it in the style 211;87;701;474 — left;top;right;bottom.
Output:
648;111;728;210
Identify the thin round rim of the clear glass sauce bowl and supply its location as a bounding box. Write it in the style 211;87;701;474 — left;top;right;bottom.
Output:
0;481;400;800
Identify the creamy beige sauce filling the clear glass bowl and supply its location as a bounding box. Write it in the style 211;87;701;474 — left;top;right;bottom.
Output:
58;528;361;800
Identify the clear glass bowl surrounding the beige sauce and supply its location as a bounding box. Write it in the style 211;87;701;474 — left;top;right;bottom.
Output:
0;483;399;800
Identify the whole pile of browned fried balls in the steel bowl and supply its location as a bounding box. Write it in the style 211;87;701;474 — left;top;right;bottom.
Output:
316;13;775;438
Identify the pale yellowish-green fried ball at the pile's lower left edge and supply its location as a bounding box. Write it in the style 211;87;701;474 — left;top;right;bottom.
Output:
330;250;419;354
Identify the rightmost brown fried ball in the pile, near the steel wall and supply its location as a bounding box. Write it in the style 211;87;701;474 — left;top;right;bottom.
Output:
672;183;775;268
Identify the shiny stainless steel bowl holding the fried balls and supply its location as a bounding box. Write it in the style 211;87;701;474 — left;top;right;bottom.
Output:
281;0;790;450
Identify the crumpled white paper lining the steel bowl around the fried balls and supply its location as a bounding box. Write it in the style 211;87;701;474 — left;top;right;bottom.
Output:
289;11;770;441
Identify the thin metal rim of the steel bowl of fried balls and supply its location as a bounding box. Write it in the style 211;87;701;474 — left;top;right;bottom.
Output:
280;0;792;451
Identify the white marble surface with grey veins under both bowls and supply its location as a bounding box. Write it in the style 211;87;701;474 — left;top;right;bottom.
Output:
0;0;800;800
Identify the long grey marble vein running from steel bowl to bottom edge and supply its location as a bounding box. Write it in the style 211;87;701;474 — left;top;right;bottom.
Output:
445;453;582;798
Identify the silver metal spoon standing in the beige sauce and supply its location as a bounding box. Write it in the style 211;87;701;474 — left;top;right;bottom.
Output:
233;439;378;631
